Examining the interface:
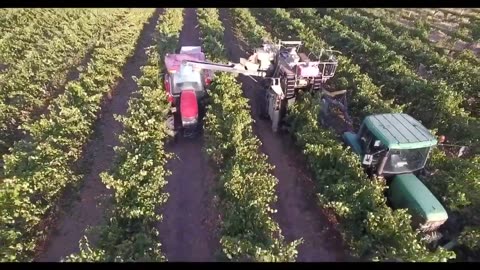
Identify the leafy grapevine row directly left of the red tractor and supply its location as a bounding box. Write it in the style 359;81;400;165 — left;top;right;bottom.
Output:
66;8;183;262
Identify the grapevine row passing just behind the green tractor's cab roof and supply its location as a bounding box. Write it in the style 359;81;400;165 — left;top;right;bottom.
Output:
292;9;480;146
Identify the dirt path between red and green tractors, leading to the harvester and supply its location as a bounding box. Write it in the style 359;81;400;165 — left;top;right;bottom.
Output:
220;9;345;262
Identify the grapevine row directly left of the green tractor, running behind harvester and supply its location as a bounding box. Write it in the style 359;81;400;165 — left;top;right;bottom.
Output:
248;9;453;261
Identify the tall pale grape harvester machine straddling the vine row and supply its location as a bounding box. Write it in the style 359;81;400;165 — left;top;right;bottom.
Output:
248;40;344;132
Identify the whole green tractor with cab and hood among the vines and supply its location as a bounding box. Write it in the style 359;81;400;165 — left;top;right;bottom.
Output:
343;113;448;235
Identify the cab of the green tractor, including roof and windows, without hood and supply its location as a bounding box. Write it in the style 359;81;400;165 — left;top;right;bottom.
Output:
344;114;437;176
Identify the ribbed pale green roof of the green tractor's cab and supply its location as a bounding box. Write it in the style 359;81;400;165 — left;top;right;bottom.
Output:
364;113;437;149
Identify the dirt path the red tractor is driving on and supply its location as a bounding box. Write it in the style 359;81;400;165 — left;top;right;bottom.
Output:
158;8;219;262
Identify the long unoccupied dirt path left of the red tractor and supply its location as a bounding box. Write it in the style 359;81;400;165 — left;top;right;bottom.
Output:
36;9;161;262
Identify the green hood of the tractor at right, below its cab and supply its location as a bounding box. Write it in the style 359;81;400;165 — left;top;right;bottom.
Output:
390;174;448;222
